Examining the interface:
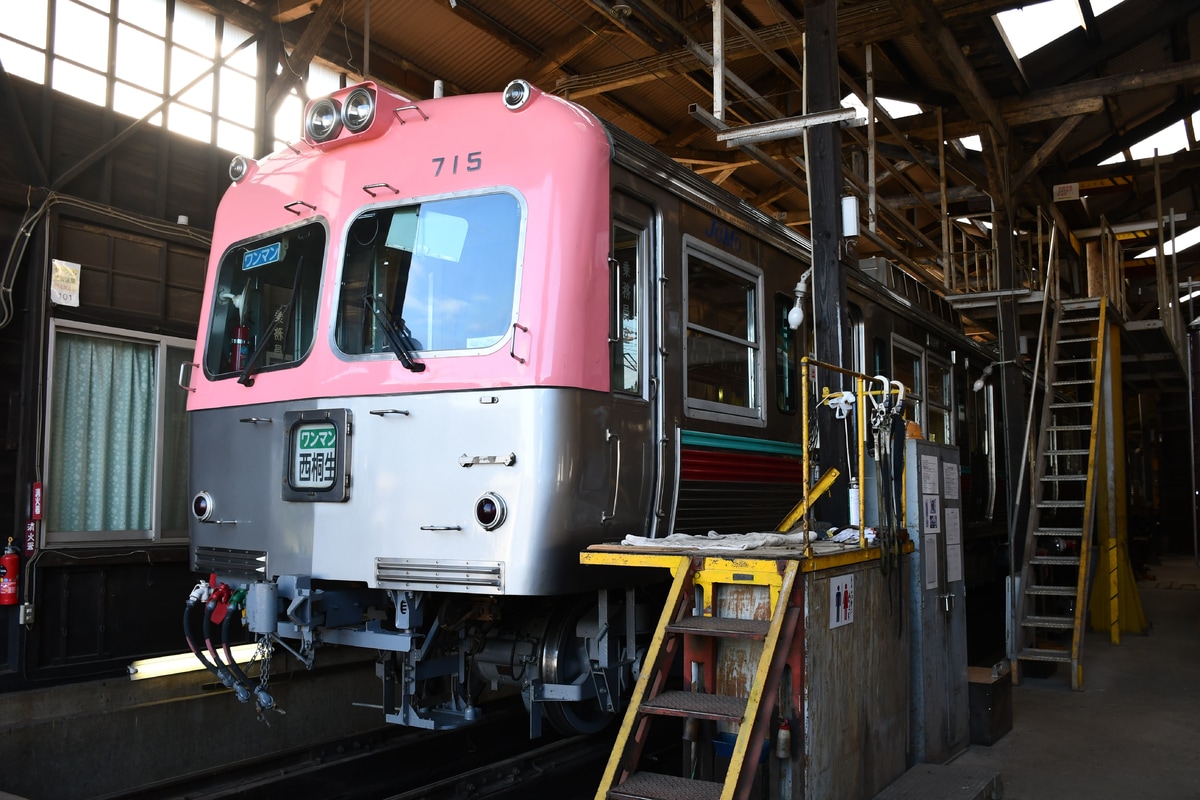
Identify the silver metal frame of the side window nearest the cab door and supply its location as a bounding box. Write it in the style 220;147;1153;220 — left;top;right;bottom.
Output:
682;235;767;427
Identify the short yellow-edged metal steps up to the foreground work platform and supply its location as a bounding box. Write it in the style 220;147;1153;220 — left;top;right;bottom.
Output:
595;555;803;800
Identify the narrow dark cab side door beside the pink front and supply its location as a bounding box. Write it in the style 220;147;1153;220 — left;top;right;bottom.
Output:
606;192;662;536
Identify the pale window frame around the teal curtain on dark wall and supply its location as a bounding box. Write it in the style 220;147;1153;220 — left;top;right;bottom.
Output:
38;317;196;549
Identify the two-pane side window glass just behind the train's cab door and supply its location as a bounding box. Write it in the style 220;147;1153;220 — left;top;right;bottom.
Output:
685;251;762;420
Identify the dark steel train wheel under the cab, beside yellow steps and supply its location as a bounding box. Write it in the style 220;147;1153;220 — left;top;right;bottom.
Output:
541;599;617;735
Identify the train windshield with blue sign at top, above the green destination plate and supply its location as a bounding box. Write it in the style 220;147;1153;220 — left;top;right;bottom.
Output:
204;222;326;381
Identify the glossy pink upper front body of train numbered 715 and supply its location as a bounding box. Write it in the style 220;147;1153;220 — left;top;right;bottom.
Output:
187;88;610;410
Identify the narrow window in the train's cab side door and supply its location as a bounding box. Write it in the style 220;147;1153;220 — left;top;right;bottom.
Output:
610;223;646;395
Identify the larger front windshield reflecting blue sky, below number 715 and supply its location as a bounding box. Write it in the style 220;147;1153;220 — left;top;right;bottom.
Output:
336;193;521;361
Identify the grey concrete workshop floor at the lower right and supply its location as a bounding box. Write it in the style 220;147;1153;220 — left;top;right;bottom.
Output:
954;557;1200;800
